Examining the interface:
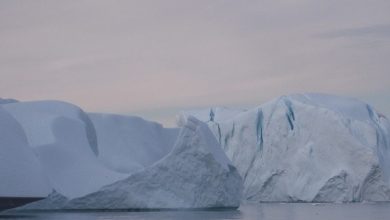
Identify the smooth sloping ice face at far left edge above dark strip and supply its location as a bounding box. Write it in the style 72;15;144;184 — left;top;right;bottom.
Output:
0;106;51;197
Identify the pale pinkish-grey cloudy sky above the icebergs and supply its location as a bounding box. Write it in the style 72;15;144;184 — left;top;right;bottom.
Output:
0;0;390;126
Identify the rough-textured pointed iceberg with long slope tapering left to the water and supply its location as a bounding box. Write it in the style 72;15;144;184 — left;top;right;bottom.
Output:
21;117;242;210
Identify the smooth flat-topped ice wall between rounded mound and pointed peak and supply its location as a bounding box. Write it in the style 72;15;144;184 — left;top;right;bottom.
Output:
88;113;179;174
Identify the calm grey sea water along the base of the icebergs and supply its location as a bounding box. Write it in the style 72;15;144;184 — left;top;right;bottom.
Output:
0;203;390;220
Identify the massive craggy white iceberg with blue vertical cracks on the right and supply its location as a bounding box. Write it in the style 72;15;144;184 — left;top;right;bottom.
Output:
191;94;390;202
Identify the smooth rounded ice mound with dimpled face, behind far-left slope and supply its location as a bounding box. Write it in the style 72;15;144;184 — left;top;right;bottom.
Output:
2;101;127;198
